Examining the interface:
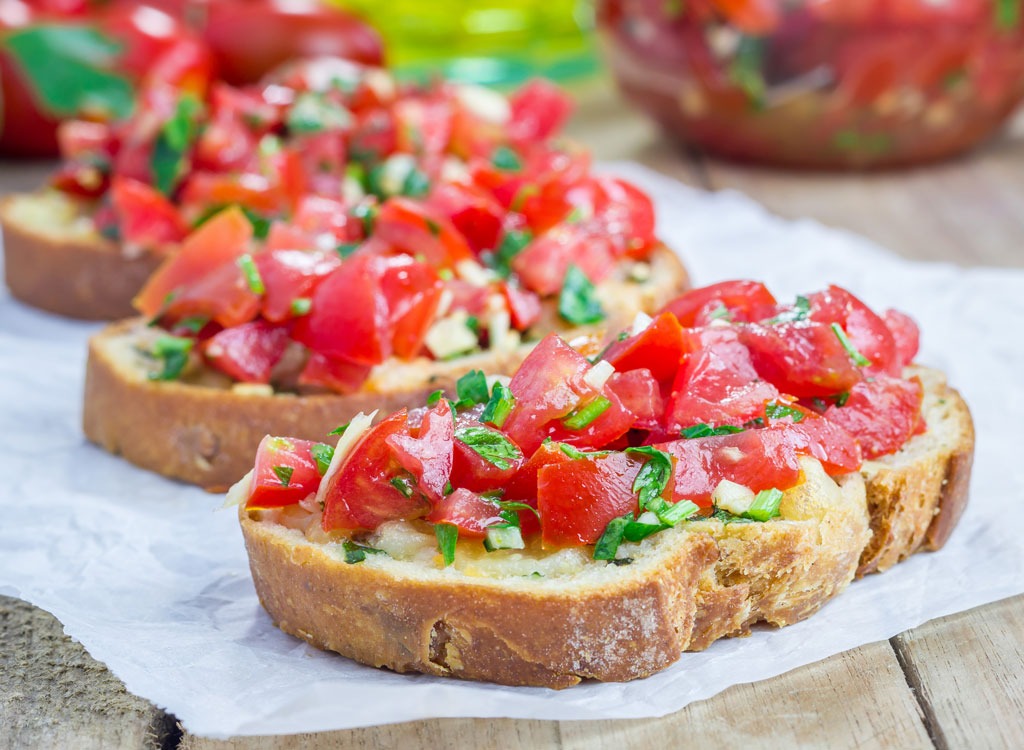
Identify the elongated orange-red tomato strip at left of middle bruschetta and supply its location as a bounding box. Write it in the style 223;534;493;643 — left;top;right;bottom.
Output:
134;208;253;318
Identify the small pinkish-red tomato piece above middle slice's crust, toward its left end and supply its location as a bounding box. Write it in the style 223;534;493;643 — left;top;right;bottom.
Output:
203;321;289;383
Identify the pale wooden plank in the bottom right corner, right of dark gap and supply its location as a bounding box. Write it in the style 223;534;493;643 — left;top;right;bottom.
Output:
893;595;1024;748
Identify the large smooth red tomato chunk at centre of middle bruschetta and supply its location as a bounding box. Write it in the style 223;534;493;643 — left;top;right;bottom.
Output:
292;255;392;365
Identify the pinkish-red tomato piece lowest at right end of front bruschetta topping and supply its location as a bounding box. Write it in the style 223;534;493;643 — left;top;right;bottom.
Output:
825;375;924;459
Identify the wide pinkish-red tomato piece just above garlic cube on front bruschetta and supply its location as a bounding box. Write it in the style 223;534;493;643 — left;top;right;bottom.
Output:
656;428;801;507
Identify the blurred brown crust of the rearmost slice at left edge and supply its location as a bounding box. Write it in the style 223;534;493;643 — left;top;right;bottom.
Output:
0;196;163;321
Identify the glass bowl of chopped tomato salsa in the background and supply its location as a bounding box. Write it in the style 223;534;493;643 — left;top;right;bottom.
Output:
597;0;1024;169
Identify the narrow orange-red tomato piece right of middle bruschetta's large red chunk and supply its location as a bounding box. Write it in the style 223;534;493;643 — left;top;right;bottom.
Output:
381;255;444;359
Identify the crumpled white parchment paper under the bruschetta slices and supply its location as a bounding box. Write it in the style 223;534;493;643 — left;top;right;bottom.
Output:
0;164;1024;738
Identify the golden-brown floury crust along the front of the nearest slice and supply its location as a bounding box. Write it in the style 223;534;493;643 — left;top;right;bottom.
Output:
240;510;716;689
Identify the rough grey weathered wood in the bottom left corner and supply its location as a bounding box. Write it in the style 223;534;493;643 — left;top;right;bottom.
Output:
0;596;176;750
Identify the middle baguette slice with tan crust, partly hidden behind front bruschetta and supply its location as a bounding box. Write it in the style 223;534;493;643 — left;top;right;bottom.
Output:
83;242;687;492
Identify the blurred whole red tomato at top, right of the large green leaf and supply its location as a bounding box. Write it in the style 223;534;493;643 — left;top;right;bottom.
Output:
203;0;384;85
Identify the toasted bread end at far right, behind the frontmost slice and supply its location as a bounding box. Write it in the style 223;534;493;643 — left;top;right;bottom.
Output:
857;367;974;576
